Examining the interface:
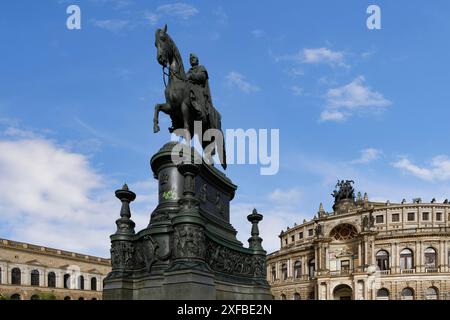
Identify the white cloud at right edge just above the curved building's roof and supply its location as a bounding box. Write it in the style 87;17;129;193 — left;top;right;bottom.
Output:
393;155;450;182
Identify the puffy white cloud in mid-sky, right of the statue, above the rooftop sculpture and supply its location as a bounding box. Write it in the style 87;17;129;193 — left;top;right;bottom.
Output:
320;76;392;121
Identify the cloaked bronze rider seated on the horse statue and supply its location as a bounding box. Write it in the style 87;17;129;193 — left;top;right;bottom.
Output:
186;53;212;120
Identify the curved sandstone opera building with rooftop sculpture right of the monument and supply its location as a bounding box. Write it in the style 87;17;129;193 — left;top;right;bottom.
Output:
267;181;450;300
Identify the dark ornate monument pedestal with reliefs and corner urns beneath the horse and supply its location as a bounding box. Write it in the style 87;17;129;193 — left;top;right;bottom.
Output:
103;142;272;300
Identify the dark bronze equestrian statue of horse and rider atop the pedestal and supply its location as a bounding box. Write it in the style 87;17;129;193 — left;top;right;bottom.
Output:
153;25;227;169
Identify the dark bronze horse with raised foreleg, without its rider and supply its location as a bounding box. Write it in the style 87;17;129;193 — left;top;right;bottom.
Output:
153;25;227;169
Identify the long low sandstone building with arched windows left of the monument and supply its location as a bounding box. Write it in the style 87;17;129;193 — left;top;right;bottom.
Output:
0;239;111;300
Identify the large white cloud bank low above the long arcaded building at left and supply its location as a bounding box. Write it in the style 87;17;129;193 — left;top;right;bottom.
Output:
0;130;156;257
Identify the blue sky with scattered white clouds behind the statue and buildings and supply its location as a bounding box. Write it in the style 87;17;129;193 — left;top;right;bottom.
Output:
0;0;450;256
